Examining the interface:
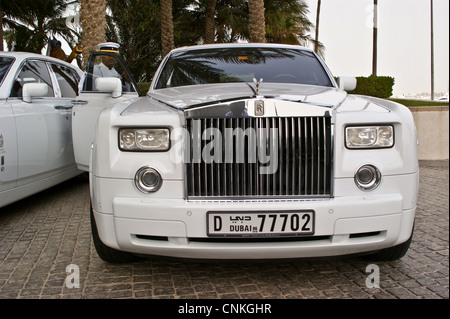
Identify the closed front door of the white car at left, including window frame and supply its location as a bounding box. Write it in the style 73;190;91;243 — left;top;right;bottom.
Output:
8;60;74;186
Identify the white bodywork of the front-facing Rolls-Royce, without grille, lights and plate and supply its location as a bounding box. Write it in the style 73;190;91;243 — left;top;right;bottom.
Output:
81;45;419;259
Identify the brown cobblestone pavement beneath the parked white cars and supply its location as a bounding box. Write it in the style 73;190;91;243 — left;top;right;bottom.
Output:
0;163;449;299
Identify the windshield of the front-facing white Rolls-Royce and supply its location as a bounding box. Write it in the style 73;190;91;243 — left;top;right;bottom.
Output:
156;47;333;89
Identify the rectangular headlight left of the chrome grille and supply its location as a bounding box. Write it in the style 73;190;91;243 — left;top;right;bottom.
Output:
119;128;170;152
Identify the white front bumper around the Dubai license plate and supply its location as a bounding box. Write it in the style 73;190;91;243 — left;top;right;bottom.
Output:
93;174;417;259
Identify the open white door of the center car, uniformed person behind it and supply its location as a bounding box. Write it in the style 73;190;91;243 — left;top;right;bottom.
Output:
72;51;139;171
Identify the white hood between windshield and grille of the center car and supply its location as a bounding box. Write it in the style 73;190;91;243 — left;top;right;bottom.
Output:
147;83;347;109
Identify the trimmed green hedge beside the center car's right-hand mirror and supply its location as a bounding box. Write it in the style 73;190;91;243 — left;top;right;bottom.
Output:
349;75;394;99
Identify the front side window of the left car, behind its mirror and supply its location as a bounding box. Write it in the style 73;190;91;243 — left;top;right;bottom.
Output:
10;61;55;97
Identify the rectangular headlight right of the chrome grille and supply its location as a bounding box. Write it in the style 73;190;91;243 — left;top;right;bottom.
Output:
345;125;394;149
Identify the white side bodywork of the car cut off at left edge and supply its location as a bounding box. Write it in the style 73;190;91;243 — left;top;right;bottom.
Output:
0;52;81;207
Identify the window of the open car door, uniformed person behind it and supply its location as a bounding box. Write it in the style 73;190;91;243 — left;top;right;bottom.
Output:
83;54;136;92
